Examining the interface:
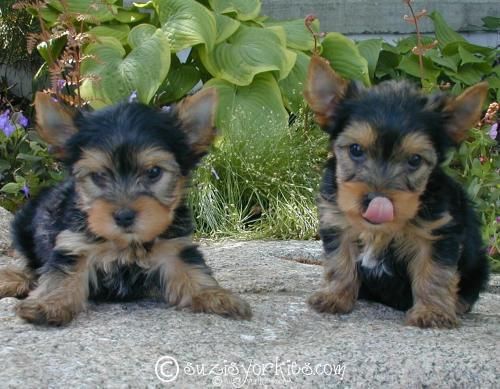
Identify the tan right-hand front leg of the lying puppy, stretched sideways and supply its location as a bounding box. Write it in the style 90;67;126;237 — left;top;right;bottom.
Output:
147;241;252;319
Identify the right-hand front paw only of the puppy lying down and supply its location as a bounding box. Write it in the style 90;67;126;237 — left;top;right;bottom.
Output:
192;288;252;320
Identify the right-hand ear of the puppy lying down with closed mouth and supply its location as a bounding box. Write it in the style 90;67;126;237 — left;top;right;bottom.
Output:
175;88;218;154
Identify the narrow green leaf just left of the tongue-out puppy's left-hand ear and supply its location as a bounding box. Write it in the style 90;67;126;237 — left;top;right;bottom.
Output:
279;51;311;112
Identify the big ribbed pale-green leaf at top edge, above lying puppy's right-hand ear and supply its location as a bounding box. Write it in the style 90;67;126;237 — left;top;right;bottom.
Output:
153;0;217;53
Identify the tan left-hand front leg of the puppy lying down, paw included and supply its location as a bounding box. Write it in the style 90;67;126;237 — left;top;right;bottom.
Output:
16;258;89;326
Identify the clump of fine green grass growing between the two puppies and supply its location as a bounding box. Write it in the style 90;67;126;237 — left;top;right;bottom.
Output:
190;108;327;239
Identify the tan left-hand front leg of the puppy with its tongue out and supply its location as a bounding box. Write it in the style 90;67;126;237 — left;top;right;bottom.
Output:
308;233;360;313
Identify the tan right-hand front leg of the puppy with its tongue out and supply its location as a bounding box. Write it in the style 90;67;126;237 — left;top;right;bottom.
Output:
406;246;459;328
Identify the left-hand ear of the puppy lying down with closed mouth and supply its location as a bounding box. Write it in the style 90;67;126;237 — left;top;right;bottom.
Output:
35;92;77;156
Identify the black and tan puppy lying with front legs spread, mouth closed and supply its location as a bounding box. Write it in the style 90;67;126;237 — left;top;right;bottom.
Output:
0;89;251;325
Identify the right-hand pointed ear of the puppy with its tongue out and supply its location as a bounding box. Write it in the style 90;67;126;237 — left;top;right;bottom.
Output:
444;82;488;144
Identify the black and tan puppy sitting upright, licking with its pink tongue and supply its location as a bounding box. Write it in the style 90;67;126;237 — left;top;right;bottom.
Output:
305;57;488;328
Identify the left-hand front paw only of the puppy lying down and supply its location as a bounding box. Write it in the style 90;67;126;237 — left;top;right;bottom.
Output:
16;298;76;326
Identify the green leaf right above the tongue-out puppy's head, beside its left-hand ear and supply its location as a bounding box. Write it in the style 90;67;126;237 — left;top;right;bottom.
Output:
321;32;370;86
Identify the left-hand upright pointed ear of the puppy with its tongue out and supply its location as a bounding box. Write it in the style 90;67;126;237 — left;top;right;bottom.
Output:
304;55;349;128
